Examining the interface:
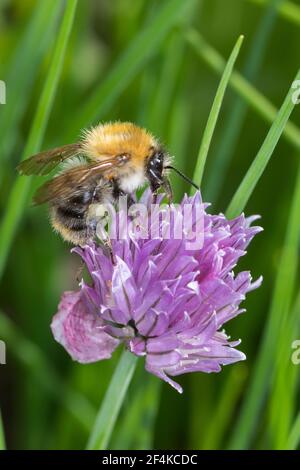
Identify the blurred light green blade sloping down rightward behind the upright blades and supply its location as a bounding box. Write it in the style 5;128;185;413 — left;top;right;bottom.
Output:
186;29;300;150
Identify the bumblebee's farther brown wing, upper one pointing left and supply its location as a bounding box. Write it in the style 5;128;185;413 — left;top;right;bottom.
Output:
17;143;81;175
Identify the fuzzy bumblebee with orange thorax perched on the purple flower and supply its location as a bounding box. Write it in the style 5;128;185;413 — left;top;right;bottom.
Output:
18;122;195;245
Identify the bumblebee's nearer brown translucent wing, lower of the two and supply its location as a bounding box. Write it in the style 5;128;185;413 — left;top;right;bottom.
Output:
33;155;128;205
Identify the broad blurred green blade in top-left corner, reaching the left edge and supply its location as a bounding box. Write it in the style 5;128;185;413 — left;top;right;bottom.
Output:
0;0;62;165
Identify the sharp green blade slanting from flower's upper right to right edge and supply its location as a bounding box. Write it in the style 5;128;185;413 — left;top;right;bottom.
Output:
226;70;300;218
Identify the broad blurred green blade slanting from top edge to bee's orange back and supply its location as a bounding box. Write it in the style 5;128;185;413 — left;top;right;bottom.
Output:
62;0;195;141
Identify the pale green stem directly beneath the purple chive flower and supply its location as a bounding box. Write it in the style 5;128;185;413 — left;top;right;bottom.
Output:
87;350;137;450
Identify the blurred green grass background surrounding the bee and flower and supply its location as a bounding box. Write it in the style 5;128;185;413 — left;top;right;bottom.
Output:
0;0;300;449
